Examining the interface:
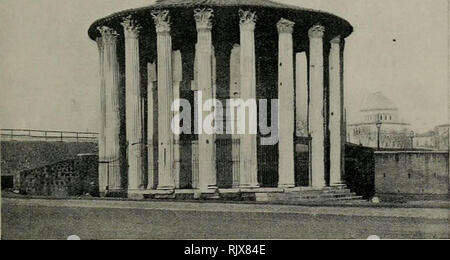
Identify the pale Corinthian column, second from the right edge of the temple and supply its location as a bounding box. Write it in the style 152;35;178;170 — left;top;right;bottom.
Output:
309;25;325;188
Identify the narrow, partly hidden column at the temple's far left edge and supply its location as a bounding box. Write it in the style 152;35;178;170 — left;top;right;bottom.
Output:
97;37;108;194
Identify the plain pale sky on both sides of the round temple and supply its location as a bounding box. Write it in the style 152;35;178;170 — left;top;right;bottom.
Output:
0;0;449;131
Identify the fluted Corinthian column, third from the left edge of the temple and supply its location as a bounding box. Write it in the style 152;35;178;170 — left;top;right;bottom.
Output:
122;17;144;190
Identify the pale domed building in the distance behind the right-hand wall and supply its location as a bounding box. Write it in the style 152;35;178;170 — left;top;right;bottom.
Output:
347;92;411;149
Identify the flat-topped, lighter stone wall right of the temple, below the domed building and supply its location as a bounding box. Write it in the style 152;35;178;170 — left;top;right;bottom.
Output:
375;151;449;200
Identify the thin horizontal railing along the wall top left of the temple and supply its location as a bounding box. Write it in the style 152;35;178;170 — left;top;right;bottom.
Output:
0;129;98;143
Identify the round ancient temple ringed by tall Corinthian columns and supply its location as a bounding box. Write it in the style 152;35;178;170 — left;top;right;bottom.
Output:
89;0;353;197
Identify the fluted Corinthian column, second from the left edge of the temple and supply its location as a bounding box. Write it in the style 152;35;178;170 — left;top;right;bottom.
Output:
98;26;122;192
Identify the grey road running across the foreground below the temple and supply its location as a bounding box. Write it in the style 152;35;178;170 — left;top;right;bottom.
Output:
2;199;449;239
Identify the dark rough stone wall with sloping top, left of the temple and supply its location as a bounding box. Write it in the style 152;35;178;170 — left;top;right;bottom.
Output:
15;155;98;197
